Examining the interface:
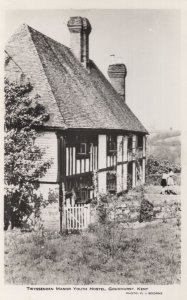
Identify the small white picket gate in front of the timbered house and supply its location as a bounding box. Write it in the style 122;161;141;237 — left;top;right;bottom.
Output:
64;204;90;230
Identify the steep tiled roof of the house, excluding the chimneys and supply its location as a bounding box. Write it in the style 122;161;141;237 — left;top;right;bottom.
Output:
6;25;147;133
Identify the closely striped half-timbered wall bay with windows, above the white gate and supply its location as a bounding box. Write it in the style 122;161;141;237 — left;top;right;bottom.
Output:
65;133;98;203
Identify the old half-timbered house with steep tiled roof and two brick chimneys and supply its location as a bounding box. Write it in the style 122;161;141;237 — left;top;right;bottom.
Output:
5;17;147;232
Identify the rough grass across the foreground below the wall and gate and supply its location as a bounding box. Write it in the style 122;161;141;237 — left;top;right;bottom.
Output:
5;222;180;285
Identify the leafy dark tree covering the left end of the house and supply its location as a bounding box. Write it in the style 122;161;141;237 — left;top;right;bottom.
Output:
4;79;52;230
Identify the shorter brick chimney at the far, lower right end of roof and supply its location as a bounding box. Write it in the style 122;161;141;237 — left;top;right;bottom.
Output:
108;64;127;101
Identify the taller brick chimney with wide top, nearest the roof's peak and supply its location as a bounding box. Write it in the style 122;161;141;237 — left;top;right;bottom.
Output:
67;17;92;67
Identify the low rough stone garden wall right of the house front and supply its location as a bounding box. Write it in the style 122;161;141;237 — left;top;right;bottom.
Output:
105;190;181;224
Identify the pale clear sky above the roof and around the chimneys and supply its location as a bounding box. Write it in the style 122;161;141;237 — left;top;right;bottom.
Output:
5;9;180;130
